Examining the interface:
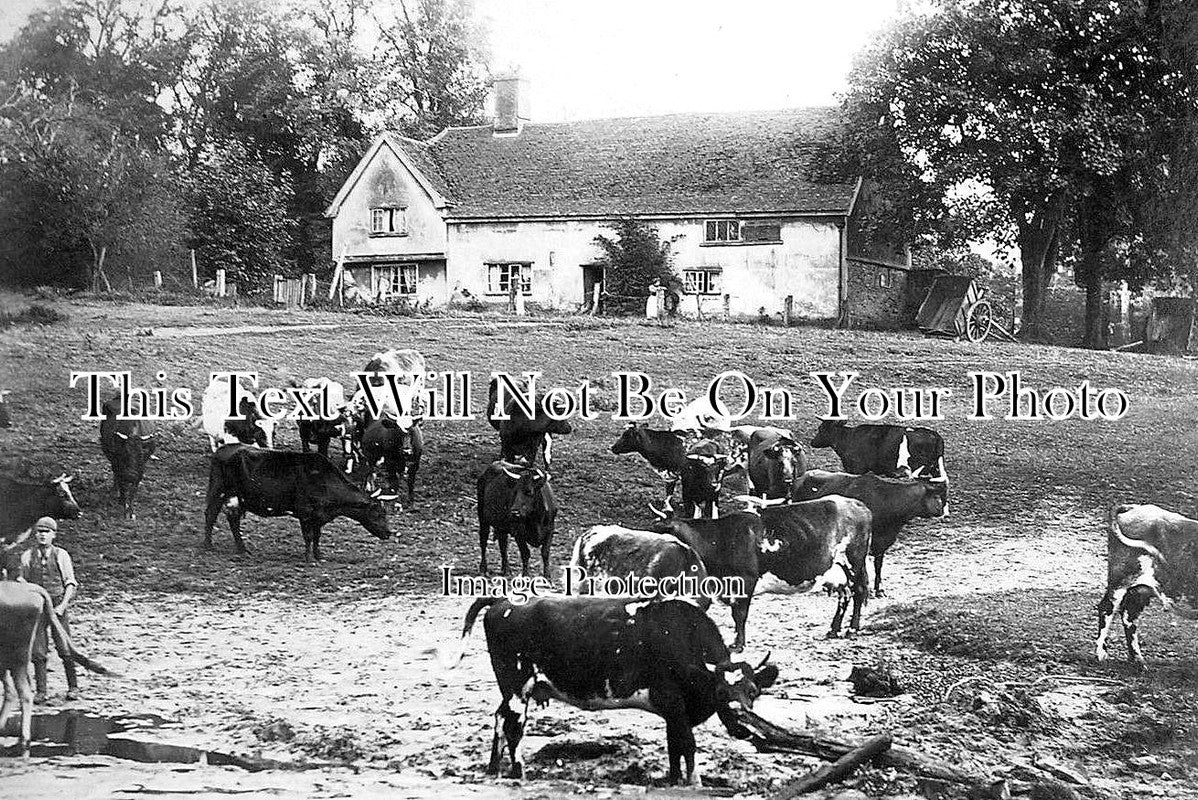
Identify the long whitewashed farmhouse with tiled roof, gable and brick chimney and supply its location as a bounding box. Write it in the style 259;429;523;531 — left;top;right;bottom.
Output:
326;78;909;327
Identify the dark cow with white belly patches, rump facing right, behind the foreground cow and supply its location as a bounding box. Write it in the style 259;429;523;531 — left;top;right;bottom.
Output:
743;495;872;638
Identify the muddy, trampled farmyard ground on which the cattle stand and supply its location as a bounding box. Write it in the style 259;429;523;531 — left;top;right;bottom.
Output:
0;302;1198;798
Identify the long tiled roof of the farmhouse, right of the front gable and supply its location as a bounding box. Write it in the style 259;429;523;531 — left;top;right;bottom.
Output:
407;108;854;218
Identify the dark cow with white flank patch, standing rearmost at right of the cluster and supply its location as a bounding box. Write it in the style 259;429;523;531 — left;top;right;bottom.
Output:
811;419;949;478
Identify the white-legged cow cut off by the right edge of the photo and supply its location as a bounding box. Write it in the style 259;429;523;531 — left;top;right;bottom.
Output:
1095;505;1198;669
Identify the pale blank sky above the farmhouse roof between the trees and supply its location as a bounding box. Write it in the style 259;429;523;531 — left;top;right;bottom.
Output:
0;0;901;122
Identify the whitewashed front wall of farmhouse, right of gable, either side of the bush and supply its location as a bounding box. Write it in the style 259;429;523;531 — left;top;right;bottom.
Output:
447;218;841;319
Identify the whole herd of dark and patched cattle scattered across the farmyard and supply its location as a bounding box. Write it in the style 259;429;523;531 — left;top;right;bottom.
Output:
0;350;1198;782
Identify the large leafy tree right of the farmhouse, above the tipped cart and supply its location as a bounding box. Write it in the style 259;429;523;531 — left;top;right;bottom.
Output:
847;0;1192;344
